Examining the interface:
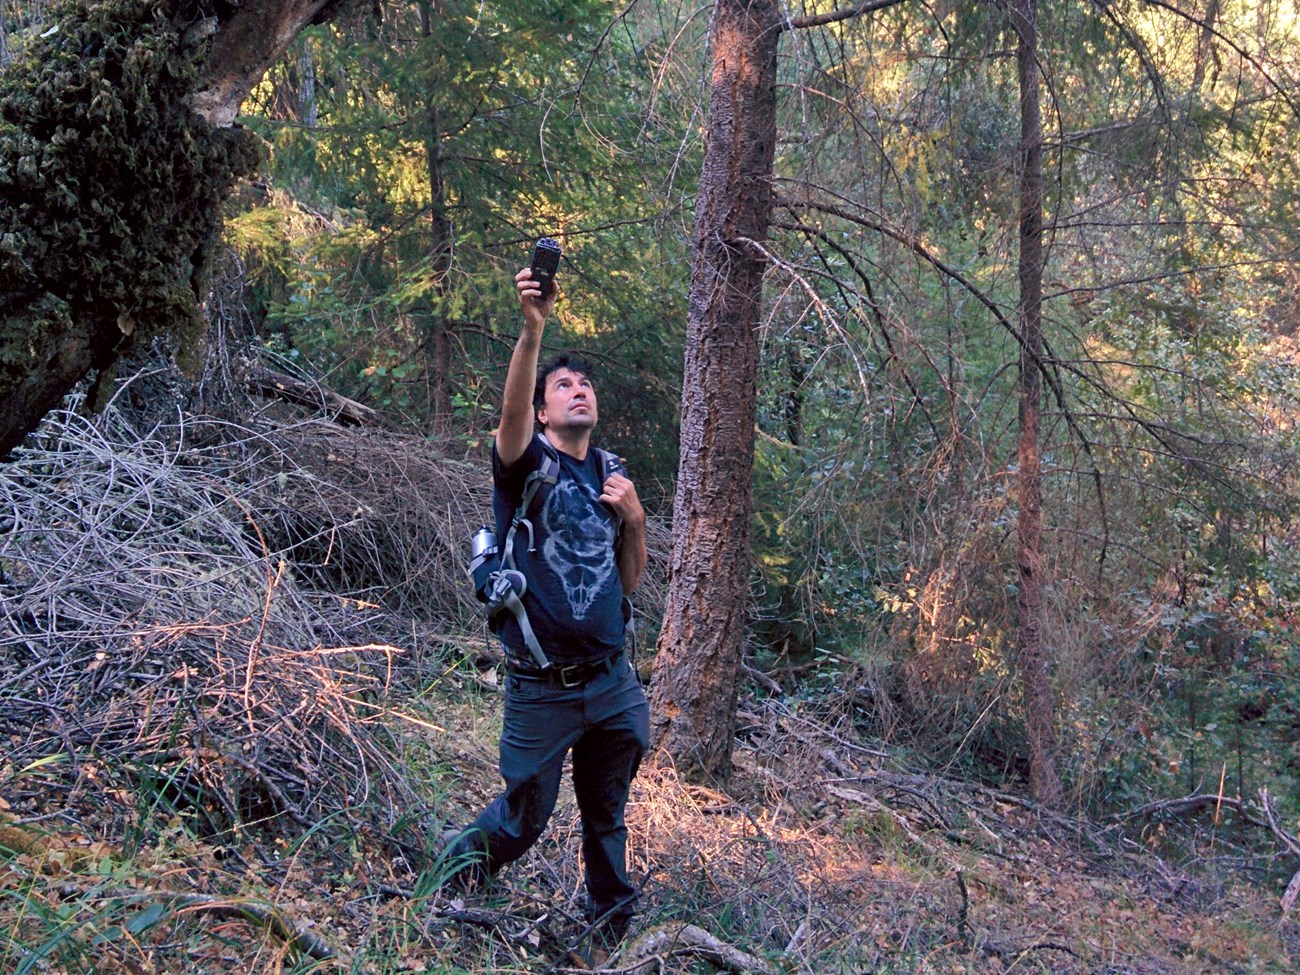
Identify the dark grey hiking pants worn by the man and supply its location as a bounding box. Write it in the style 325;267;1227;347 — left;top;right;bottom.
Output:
450;657;650;930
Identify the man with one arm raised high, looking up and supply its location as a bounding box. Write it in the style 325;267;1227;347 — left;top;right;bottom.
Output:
449;268;650;945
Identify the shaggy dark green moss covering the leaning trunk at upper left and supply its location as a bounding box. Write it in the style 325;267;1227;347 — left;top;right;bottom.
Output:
0;0;259;395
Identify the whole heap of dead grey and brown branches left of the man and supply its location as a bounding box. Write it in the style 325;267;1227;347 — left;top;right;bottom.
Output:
0;392;667;857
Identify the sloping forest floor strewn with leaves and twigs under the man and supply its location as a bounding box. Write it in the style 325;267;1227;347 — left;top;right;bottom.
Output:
0;659;1300;975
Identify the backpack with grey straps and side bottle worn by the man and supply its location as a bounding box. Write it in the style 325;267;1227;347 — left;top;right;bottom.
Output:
467;434;632;670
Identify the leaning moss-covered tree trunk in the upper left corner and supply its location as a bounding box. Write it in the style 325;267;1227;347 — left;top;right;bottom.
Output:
0;0;356;456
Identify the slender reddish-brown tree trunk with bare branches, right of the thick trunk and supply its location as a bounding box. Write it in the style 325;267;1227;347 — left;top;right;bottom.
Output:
1010;0;1061;806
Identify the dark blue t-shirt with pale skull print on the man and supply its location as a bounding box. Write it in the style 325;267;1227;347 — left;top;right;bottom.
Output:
491;434;624;664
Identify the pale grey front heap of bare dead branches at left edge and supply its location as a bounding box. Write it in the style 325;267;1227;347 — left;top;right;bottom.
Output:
0;411;439;847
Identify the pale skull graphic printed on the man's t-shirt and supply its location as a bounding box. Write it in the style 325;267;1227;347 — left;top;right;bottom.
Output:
542;477;618;620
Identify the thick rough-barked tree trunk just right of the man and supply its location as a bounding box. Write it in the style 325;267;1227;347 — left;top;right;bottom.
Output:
650;0;781;780
